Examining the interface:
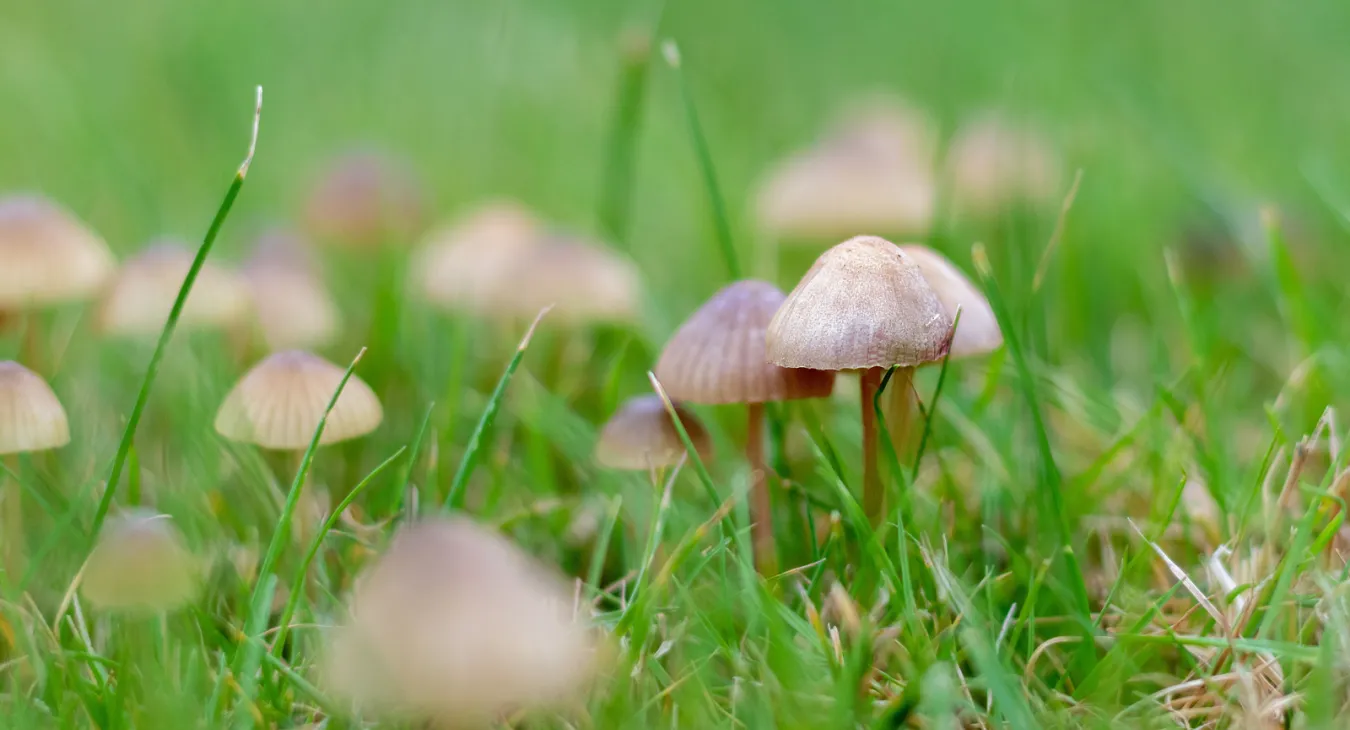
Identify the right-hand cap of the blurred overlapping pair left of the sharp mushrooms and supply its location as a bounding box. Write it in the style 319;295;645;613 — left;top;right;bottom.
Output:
495;235;641;325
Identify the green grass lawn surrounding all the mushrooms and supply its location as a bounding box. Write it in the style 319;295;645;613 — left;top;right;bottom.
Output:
0;0;1350;730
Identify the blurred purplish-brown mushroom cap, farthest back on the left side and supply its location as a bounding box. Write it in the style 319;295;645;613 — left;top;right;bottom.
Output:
305;151;424;248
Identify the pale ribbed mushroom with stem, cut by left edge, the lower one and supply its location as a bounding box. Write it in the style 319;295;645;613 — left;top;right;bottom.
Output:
0;360;70;574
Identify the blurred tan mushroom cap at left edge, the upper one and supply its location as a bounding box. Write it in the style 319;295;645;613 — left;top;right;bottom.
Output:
0;196;116;309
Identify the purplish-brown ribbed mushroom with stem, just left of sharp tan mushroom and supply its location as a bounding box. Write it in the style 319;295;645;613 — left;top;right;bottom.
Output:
655;281;834;571
